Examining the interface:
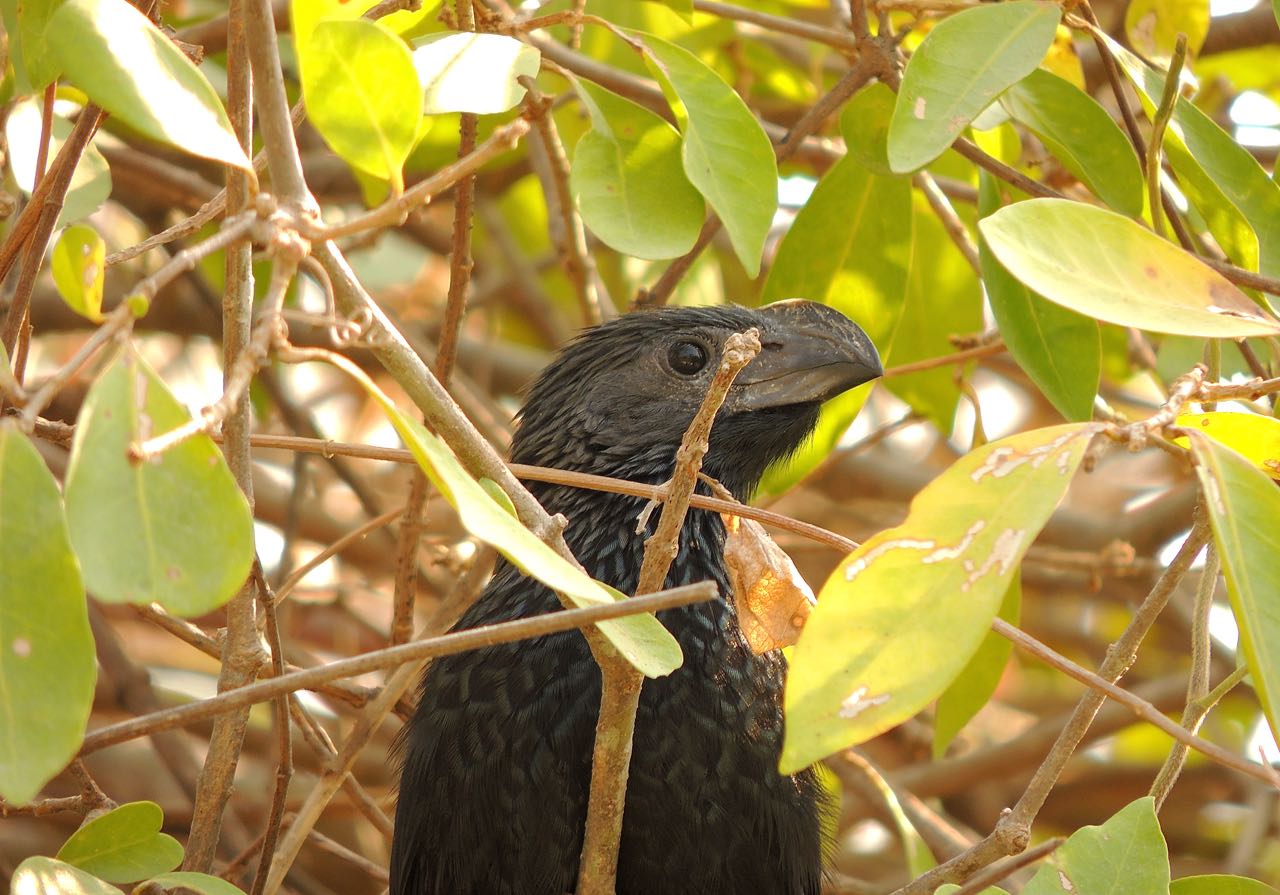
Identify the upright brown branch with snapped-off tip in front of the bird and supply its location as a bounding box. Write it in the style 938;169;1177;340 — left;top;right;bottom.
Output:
576;329;760;895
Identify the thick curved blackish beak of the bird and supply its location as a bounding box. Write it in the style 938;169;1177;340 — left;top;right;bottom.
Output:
730;298;884;411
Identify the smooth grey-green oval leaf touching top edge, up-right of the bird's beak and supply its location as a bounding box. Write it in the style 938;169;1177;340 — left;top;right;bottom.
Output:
888;0;1062;173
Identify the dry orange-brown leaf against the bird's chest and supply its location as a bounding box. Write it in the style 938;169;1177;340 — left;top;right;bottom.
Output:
722;516;817;654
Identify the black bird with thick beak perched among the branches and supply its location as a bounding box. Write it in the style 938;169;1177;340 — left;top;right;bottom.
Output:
390;300;881;895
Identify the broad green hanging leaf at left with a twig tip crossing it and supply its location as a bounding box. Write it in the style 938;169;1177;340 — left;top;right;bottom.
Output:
67;347;253;616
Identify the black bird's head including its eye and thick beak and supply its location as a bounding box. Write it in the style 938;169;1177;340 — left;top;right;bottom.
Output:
512;298;882;497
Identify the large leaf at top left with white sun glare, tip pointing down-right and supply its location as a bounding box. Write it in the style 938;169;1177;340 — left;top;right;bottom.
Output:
47;0;250;169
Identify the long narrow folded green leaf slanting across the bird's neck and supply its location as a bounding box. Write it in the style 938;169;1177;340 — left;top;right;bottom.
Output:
338;362;684;677
